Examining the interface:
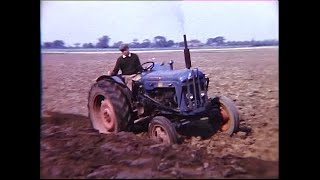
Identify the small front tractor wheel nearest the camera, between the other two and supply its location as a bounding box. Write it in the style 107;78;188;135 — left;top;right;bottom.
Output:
148;116;178;144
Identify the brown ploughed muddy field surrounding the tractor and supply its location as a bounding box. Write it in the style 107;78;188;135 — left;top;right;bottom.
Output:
40;49;279;178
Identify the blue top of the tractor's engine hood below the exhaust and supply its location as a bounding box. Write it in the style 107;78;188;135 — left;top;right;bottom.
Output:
142;69;204;82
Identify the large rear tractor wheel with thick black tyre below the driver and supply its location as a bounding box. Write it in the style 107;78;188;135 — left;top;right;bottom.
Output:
88;80;131;134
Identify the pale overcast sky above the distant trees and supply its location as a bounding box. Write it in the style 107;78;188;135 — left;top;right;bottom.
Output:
40;0;279;45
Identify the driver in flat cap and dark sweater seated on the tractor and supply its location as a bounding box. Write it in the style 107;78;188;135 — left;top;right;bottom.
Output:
108;44;143;91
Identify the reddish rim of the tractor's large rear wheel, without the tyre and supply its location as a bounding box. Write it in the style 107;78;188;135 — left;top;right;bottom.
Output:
94;95;117;131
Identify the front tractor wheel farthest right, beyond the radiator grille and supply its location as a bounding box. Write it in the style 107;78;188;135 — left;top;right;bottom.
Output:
219;96;240;136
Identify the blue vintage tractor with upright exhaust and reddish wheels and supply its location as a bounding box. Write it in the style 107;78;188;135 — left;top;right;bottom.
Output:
88;35;239;144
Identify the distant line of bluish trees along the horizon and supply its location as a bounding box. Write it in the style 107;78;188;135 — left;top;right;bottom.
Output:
41;35;279;49
